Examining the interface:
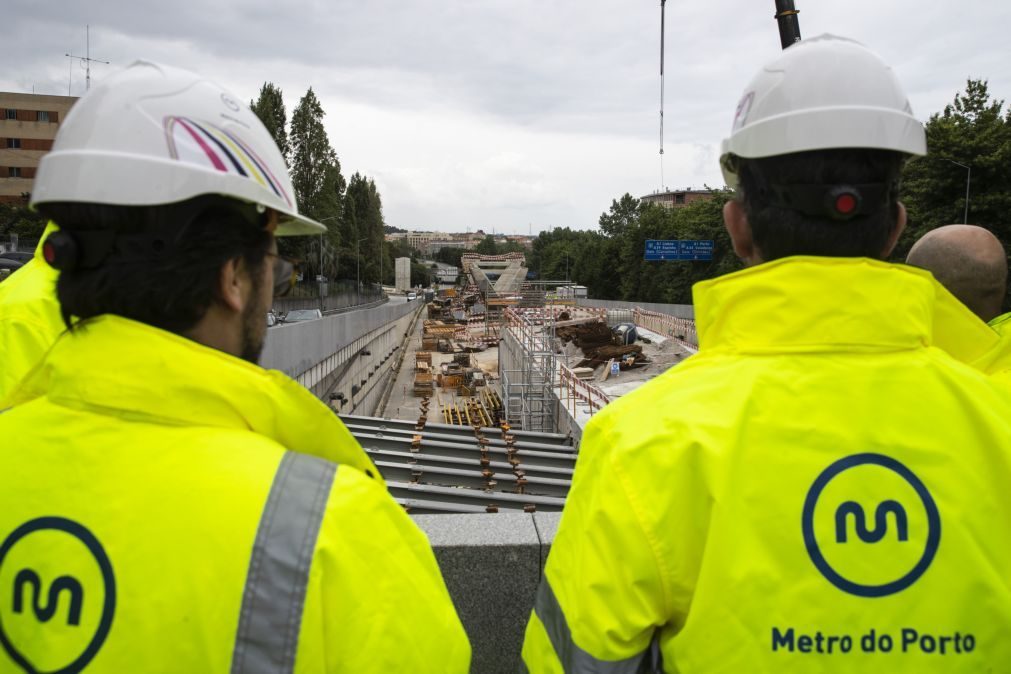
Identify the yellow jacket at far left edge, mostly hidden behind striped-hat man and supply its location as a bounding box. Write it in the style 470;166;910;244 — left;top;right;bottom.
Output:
0;223;67;409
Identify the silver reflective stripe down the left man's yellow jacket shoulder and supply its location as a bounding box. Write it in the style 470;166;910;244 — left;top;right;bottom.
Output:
232;452;337;674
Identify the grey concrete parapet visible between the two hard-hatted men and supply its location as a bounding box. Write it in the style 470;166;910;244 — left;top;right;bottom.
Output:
413;512;561;674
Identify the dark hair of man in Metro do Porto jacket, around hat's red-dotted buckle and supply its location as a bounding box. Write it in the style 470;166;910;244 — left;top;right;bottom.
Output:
737;149;905;262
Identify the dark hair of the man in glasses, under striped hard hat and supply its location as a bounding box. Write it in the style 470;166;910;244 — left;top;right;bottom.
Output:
38;197;271;333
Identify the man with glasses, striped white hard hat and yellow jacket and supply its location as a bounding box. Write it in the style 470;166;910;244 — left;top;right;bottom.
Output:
0;62;470;673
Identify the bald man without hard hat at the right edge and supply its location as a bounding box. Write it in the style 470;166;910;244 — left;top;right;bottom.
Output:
906;224;1011;384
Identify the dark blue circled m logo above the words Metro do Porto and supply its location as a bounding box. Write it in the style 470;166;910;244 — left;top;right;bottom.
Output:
801;453;941;597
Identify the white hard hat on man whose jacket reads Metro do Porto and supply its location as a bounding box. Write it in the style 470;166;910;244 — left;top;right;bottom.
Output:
720;35;927;187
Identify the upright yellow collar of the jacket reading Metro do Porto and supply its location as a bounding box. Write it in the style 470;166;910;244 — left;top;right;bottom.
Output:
693;257;997;364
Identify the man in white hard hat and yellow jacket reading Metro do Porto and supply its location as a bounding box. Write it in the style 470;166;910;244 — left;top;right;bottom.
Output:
523;36;1011;674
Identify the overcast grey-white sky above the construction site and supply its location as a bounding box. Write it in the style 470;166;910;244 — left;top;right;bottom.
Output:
0;0;1011;233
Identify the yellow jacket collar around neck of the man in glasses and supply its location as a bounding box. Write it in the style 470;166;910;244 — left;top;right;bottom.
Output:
11;314;379;477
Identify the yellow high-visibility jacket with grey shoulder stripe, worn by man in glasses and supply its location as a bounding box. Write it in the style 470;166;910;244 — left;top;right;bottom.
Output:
0;315;470;674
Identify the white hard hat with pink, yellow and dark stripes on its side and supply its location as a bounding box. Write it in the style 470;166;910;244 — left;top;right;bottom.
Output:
31;61;326;236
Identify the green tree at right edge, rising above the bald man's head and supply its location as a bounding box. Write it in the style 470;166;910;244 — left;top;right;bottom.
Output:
894;80;1011;261
